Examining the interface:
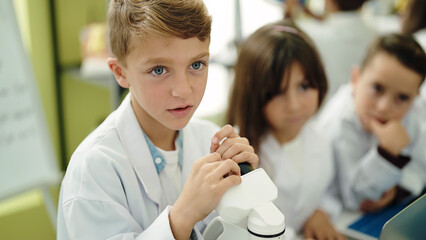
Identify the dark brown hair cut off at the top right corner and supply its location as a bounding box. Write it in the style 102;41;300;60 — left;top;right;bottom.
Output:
402;0;426;34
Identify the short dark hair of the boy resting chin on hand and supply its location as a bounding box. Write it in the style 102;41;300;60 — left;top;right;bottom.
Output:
361;33;426;82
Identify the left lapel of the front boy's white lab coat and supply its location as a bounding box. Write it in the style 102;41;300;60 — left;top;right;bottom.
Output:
117;94;167;211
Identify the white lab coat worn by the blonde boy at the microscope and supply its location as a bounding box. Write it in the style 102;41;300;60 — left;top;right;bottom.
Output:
57;94;219;240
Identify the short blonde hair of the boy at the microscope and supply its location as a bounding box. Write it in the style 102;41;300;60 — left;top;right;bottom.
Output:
108;0;212;65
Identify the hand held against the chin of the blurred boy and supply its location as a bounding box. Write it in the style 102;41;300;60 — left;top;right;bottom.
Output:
369;120;410;156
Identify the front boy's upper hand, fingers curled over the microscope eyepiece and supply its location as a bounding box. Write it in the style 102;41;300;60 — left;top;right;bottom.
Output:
210;125;259;169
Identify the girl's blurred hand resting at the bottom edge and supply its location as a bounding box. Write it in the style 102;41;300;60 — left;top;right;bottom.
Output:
303;210;346;240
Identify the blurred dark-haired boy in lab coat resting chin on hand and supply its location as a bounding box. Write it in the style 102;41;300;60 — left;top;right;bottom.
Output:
319;34;426;212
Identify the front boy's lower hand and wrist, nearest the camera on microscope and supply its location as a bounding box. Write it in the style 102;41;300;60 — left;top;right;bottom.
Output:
169;153;241;239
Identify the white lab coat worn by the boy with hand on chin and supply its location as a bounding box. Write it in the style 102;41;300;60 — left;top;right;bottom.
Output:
318;84;426;210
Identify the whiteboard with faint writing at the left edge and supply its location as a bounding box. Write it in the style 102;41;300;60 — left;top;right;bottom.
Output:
0;0;61;199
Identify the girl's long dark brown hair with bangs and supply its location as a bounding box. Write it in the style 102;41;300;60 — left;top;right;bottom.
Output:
226;20;328;150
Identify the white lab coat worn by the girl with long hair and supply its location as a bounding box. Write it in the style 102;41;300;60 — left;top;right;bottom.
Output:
259;120;341;232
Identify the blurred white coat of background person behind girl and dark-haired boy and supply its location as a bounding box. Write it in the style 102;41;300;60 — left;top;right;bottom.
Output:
298;11;378;100
